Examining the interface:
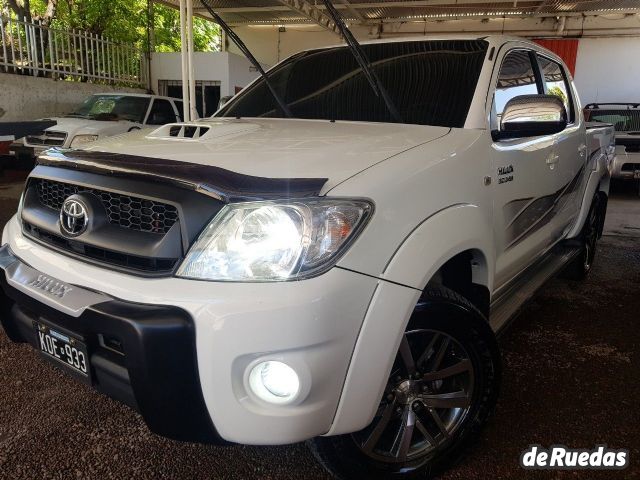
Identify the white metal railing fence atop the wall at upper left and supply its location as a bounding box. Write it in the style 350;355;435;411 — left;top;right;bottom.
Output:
0;16;148;87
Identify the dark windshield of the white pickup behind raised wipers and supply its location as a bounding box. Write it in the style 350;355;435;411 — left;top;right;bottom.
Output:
216;40;488;127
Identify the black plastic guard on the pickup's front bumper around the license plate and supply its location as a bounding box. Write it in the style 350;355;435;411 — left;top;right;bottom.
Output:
0;245;226;444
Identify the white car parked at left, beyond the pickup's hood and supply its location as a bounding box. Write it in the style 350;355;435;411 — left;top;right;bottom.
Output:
12;93;182;157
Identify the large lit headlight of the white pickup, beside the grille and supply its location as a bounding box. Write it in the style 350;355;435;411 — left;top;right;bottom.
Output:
177;199;373;281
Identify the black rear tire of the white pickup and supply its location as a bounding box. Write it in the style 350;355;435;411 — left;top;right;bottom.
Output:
562;193;606;281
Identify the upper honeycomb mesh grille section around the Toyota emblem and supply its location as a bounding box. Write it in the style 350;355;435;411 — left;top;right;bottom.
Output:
34;179;178;235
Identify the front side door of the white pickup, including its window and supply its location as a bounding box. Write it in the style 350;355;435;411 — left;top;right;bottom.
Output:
491;48;559;288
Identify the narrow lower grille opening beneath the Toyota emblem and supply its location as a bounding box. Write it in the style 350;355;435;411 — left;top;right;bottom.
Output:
24;222;177;274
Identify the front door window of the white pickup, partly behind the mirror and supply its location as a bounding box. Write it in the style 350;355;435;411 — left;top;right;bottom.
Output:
494;50;541;120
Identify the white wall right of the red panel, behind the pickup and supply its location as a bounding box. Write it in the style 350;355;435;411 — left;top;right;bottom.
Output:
575;37;640;105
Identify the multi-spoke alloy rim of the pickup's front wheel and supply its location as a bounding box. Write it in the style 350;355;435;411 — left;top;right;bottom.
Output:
353;329;474;463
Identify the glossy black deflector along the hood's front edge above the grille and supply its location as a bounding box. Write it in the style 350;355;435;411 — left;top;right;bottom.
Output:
38;148;328;203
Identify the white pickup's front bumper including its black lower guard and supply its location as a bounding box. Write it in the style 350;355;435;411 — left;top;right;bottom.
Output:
0;217;384;445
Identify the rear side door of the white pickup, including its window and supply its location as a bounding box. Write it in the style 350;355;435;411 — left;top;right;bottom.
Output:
536;53;589;235
